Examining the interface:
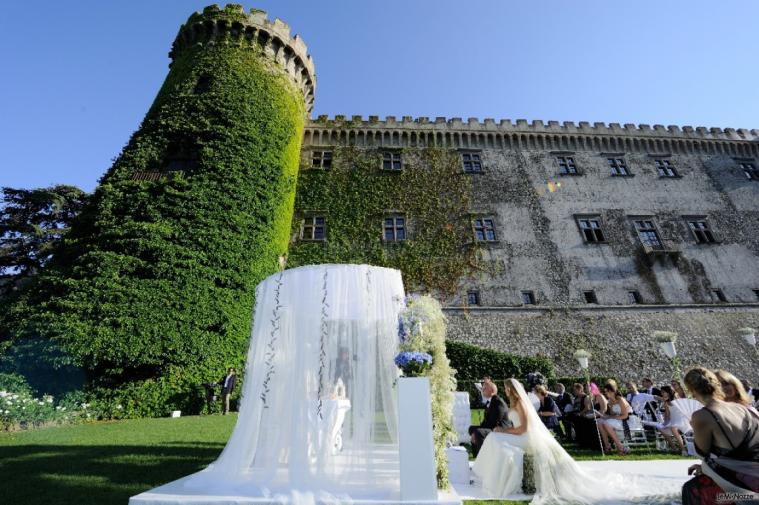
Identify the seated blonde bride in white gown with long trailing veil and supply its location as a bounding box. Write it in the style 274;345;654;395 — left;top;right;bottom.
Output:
472;379;681;505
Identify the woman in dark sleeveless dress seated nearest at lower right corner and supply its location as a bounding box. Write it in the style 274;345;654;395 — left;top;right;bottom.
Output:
682;367;759;505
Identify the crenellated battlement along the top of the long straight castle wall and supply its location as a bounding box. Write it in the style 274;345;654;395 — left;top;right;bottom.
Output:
304;115;759;158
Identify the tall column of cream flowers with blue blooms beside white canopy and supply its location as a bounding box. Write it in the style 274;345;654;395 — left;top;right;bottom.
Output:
396;295;456;489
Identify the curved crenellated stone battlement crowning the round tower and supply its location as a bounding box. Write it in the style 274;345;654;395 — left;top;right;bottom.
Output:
169;4;316;113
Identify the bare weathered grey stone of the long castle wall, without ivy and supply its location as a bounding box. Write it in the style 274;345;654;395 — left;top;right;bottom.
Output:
301;116;759;381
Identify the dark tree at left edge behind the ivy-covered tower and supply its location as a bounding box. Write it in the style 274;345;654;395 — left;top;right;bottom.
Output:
0;185;87;292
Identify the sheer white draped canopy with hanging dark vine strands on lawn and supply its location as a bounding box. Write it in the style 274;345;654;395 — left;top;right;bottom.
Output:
183;265;404;503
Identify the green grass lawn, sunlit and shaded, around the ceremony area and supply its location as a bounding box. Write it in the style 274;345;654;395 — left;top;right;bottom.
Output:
0;411;680;505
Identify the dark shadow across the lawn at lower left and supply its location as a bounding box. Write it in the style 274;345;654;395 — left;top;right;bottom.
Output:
0;442;224;505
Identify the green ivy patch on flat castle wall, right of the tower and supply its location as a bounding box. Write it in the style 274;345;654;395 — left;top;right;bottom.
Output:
288;147;477;294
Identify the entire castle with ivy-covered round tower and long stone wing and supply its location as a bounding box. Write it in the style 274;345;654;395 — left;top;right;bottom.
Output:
12;5;759;415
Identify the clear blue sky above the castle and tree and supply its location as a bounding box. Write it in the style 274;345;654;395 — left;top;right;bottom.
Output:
0;0;759;191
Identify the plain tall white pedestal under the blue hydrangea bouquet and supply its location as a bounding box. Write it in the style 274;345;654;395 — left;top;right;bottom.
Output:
398;377;438;501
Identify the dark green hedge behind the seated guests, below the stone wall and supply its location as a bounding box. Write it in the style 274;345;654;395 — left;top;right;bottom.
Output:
445;340;555;408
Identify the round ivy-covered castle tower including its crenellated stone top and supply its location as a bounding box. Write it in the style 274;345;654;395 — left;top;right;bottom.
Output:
6;5;315;415
